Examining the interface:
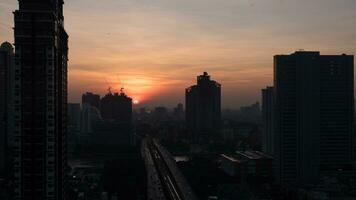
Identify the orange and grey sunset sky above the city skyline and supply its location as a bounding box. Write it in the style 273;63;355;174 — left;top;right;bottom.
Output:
0;0;356;108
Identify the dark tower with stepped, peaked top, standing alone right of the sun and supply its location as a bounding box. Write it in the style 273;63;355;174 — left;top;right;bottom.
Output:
185;72;221;141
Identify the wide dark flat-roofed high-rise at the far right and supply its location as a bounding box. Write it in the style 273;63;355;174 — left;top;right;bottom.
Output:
274;52;354;185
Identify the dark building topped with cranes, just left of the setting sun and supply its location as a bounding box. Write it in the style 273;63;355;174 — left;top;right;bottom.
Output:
100;91;132;123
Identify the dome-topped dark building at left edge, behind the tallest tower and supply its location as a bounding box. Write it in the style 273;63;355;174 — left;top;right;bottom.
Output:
0;42;14;177
